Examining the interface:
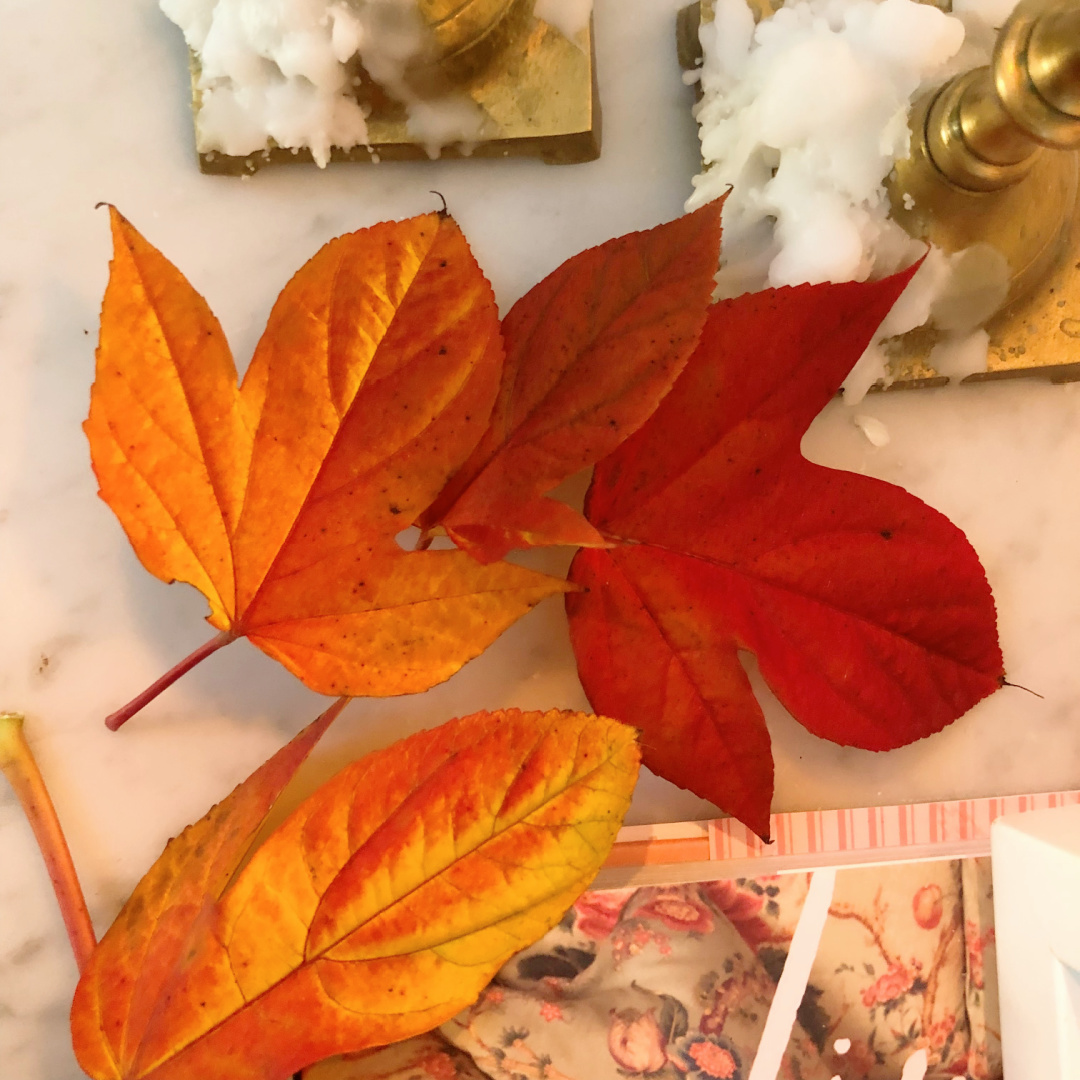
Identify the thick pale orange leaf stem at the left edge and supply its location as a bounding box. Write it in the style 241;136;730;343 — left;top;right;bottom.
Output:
0;713;97;971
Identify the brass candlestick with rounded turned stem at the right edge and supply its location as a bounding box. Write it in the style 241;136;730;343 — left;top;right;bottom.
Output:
678;0;1080;389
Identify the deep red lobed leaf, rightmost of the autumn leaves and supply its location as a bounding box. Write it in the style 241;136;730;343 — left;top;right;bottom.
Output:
566;272;1003;836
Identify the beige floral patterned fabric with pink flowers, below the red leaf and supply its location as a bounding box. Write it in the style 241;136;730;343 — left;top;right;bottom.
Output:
309;860;1001;1080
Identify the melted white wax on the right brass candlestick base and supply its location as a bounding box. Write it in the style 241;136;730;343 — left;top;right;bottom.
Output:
687;0;1014;403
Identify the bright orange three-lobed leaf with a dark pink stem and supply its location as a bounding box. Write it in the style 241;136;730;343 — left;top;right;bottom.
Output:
85;211;565;717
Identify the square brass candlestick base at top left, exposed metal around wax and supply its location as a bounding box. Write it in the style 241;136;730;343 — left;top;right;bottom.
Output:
191;0;600;176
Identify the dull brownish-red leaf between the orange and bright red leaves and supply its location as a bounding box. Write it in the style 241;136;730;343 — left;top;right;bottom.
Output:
420;200;723;563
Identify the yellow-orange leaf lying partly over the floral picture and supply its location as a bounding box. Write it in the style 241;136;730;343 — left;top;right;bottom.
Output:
71;710;639;1080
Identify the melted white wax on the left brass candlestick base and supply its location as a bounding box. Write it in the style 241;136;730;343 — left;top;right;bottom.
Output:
161;0;592;166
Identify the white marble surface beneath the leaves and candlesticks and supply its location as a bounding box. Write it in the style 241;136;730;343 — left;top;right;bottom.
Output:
0;0;1080;1080
